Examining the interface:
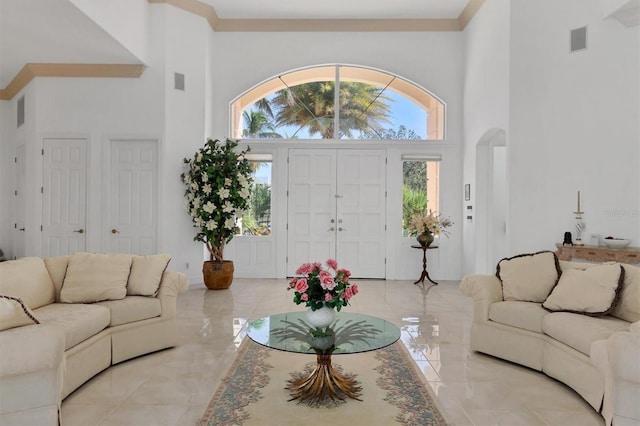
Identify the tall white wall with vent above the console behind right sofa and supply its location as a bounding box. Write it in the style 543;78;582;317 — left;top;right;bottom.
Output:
507;0;640;253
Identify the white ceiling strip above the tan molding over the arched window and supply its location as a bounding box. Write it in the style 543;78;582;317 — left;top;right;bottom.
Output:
200;0;469;19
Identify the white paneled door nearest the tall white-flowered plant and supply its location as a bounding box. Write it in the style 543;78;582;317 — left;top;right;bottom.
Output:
107;139;158;254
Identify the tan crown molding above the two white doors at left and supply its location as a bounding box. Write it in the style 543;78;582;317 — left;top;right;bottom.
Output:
0;63;145;100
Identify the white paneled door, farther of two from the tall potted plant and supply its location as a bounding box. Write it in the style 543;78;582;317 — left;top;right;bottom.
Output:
42;138;87;257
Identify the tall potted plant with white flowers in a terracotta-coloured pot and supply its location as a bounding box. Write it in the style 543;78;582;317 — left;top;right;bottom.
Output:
180;139;253;289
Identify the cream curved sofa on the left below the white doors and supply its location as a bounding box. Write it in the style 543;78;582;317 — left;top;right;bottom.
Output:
0;253;188;425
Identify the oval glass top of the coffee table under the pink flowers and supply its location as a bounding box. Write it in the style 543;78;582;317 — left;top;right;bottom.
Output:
247;311;400;354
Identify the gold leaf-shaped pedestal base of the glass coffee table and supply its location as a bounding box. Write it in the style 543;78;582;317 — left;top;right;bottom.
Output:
286;354;362;405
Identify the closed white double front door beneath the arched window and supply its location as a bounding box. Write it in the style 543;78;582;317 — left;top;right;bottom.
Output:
287;149;386;278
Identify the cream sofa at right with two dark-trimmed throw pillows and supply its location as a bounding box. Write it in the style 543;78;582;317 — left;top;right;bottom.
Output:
460;252;640;426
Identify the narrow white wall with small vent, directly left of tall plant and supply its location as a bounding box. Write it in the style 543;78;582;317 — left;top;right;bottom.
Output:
160;6;211;283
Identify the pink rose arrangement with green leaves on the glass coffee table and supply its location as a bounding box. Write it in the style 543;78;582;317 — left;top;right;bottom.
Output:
287;259;358;312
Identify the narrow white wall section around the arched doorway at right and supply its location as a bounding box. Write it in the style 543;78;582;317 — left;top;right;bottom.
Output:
462;0;510;275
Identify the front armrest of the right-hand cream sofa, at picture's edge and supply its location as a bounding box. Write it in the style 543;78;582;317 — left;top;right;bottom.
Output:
607;321;640;425
